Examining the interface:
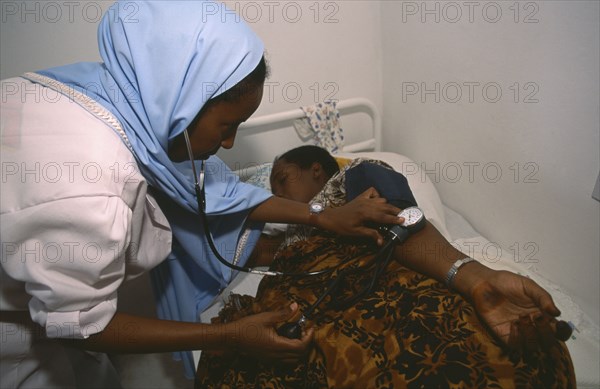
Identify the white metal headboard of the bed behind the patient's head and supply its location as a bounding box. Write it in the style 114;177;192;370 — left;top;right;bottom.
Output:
217;97;381;170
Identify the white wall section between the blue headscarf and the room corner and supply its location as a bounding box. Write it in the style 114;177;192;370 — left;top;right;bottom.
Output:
220;1;382;114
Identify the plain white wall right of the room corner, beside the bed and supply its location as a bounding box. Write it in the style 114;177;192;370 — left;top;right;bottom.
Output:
382;1;600;322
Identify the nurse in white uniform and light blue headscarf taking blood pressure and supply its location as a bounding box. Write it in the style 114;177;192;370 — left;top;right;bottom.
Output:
0;1;401;388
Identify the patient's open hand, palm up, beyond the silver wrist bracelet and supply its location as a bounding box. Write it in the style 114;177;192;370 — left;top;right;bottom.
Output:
465;269;572;350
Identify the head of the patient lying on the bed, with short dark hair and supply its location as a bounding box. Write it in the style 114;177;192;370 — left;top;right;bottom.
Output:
270;146;339;203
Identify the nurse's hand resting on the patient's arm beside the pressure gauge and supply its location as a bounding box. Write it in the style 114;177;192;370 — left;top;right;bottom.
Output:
315;188;404;245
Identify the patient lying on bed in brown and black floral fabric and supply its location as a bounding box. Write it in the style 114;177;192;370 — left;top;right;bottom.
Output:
196;146;575;388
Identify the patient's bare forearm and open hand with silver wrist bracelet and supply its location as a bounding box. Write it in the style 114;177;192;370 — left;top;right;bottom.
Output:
395;222;570;349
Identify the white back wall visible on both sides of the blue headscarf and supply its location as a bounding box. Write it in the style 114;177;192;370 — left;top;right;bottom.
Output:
0;0;382;109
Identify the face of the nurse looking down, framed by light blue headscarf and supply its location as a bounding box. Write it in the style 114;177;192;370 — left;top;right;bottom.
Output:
169;85;263;162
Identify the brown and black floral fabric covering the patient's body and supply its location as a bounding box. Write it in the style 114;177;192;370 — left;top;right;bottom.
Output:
197;235;575;388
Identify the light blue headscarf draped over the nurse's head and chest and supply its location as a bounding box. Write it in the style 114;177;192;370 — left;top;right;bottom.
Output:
28;0;271;375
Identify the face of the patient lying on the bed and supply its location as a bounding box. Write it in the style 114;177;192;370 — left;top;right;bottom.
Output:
270;160;326;203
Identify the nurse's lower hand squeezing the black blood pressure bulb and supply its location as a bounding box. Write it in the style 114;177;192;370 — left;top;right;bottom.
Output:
224;303;314;363
